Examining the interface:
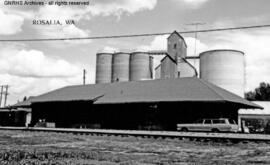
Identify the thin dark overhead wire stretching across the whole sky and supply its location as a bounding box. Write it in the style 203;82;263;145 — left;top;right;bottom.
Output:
0;24;270;42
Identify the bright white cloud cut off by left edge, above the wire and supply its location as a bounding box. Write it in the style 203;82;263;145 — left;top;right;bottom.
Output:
0;9;24;35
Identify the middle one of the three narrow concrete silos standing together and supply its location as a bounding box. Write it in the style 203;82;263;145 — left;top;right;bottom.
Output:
112;52;130;82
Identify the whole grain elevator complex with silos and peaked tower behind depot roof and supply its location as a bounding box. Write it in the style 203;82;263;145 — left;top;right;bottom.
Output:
96;31;245;97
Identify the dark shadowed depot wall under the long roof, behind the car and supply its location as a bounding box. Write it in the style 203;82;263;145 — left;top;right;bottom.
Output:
32;101;238;130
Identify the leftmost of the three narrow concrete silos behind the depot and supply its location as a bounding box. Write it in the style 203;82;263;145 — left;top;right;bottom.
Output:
96;53;112;84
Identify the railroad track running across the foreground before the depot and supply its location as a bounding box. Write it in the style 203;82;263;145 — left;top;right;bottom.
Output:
0;127;270;142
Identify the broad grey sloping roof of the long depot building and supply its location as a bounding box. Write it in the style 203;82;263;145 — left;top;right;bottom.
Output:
29;78;262;108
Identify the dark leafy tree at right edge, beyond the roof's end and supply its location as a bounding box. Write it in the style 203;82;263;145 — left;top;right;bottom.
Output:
245;82;270;101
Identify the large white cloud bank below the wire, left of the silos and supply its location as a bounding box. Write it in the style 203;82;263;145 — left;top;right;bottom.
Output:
0;47;86;104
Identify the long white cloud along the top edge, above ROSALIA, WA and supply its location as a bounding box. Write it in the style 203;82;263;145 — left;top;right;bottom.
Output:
35;0;157;21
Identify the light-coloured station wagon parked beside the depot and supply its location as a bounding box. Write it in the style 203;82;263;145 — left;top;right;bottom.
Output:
177;118;238;132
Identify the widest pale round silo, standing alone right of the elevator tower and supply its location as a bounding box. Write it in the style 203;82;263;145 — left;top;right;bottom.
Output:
200;50;245;97
